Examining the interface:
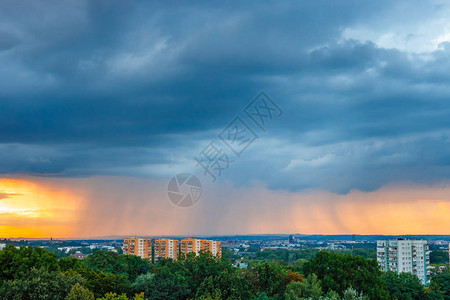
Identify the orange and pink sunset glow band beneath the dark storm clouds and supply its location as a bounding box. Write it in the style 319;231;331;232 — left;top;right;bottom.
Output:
0;177;450;238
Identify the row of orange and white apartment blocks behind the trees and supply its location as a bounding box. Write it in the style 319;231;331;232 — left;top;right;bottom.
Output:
123;238;222;260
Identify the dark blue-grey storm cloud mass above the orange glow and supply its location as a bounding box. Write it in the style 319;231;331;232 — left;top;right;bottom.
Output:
0;1;450;192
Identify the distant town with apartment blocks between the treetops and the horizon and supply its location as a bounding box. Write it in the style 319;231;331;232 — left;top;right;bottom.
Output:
0;235;450;286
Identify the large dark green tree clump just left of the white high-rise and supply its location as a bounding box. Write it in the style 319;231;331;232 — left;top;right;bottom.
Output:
303;251;388;299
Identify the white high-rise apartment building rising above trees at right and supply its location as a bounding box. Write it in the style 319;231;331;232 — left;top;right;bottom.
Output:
377;239;430;286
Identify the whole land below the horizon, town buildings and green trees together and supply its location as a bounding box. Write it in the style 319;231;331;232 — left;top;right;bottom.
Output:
0;234;450;300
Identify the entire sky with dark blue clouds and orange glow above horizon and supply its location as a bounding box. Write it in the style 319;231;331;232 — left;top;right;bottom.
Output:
0;0;450;238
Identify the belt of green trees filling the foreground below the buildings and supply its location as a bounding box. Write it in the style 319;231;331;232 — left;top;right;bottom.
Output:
0;246;436;300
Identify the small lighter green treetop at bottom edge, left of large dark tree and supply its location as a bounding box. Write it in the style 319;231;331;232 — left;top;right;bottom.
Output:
284;274;322;300
